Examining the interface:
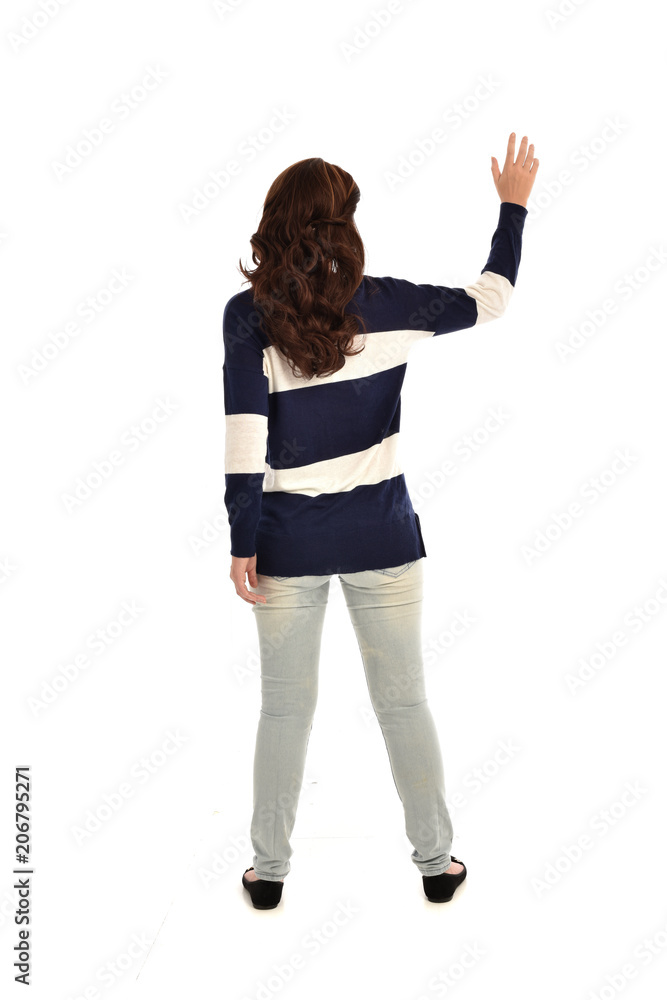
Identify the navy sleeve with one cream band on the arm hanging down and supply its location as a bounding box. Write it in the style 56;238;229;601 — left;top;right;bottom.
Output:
222;299;269;558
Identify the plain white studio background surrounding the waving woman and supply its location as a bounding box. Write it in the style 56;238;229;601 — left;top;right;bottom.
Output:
0;0;667;1000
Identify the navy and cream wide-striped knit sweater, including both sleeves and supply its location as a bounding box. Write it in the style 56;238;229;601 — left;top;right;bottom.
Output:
222;202;528;576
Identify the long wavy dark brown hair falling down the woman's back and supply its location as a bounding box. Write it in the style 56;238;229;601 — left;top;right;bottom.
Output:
239;156;365;379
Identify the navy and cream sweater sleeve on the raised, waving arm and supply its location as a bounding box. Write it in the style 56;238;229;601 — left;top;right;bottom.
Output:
372;201;528;335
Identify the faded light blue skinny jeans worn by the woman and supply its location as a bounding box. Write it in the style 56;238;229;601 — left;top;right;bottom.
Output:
249;559;453;882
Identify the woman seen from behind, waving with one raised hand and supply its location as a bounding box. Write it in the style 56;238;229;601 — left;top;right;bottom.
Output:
223;133;538;909
